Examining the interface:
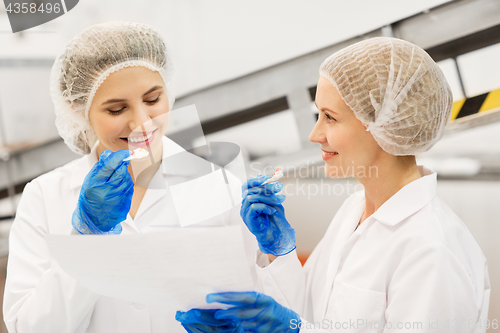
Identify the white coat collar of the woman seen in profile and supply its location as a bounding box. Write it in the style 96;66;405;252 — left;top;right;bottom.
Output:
371;165;437;226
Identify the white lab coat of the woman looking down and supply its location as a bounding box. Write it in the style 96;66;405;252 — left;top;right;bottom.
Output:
3;137;258;333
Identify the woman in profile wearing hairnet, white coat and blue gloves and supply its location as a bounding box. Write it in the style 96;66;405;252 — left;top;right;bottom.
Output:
177;37;490;333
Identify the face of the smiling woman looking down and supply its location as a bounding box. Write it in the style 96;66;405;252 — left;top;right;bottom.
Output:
89;66;169;160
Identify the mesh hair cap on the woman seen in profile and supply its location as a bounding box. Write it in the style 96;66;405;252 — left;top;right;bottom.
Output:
319;37;453;155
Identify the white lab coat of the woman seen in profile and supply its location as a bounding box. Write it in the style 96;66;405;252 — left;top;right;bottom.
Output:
258;166;490;333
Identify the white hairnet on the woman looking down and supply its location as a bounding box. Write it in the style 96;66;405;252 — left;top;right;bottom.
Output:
50;22;174;154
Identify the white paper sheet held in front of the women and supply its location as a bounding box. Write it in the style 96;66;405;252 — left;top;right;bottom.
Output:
46;226;253;311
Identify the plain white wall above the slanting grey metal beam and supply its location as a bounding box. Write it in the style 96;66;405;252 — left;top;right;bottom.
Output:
0;0;450;94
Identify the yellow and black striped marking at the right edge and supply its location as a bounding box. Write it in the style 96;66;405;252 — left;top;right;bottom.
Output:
450;89;500;121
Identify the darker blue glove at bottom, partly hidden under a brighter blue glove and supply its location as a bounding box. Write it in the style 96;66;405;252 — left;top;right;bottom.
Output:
175;309;243;333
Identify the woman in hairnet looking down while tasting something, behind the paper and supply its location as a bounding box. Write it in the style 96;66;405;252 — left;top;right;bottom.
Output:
4;22;257;333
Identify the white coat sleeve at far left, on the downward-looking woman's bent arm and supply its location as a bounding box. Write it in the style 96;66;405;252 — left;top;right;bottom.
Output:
3;181;99;333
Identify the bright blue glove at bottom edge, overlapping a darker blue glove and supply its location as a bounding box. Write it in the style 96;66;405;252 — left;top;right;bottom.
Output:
207;292;301;333
